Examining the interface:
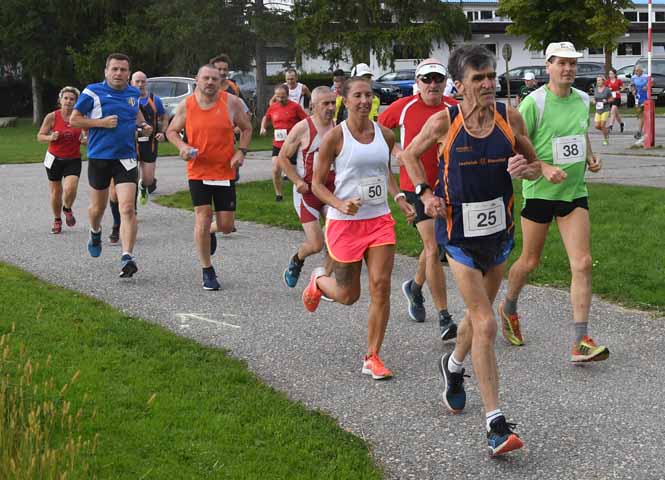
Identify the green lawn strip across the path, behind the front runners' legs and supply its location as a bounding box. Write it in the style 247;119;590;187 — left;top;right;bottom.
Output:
156;181;665;312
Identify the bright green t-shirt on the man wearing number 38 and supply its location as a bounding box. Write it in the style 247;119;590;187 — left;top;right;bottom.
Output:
519;85;589;202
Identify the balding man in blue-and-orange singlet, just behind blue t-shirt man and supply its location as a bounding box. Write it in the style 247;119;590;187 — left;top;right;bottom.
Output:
131;71;169;205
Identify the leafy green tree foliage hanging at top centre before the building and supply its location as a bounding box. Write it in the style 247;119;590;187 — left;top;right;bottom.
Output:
294;0;469;67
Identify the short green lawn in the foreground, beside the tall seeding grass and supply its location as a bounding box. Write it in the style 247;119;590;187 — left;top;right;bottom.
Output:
0;263;382;479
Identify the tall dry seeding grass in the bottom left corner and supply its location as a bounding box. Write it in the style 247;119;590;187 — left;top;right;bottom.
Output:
0;326;99;480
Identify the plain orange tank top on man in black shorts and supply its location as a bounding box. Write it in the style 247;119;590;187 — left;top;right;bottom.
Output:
185;92;236;180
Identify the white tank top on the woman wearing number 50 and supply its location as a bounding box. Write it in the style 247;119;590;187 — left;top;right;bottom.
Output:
328;120;390;220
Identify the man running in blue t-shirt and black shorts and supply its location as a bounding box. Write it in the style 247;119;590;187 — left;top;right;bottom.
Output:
70;53;152;278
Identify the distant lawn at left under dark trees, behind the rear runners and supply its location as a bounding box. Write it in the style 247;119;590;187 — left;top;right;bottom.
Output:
0;118;272;164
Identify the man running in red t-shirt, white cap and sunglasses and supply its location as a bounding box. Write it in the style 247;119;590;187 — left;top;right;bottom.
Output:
379;58;458;340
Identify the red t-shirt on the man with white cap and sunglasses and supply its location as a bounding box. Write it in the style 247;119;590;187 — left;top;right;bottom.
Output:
379;95;459;192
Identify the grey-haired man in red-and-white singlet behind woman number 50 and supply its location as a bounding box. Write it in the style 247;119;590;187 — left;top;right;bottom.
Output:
279;87;335;288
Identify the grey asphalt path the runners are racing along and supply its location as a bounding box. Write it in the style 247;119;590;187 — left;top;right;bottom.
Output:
0;137;665;479
